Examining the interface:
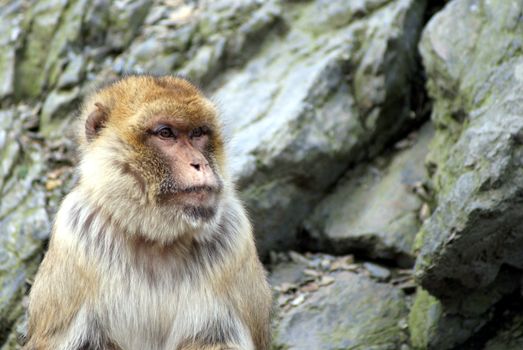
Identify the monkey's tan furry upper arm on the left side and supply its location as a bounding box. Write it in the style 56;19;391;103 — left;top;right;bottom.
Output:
24;234;103;350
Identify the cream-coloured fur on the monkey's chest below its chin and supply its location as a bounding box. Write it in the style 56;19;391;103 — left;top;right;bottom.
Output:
56;194;254;350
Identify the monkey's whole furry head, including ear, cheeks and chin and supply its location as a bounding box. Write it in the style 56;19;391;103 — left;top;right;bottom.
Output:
78;76;228;240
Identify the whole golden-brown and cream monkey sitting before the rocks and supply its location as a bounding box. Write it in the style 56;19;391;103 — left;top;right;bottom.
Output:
24;75;272;350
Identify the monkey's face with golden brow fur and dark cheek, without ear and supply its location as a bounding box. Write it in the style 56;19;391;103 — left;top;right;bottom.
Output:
118;95;227;221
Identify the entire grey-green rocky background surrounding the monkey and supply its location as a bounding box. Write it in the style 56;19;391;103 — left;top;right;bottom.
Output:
0;0;523;350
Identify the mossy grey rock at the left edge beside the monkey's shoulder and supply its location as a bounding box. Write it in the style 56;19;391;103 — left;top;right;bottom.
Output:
0;106;50;344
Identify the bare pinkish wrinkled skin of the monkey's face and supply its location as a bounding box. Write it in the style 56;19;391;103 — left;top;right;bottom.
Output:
145;118;222;217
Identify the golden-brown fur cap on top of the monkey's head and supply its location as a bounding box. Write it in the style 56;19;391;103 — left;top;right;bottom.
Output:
77;75;224;165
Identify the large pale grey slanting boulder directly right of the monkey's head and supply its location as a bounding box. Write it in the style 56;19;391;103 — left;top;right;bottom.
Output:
214;0;424;254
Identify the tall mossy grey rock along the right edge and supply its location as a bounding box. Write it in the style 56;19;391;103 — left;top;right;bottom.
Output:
416;0;523;306
